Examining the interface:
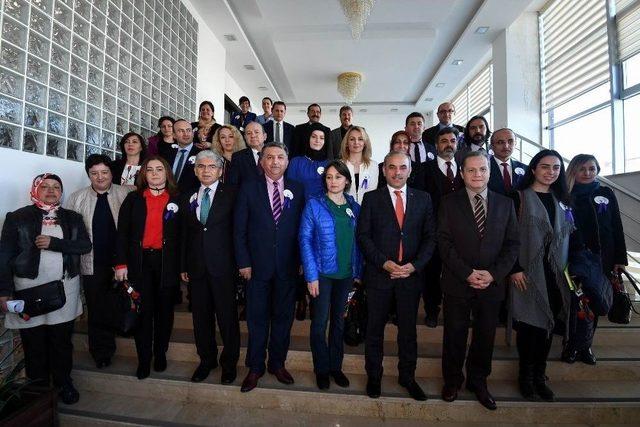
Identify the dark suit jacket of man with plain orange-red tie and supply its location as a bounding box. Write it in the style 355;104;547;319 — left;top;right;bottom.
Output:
356;187;436;289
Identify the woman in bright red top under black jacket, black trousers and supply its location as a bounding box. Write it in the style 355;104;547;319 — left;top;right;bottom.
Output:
116;156;181;379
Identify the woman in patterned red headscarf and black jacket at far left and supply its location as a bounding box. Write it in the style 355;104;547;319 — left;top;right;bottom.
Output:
0;173;91;404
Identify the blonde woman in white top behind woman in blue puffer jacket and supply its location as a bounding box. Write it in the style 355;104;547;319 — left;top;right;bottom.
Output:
340;126;378;203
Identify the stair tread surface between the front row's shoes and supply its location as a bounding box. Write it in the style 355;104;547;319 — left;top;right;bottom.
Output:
72;352;640;403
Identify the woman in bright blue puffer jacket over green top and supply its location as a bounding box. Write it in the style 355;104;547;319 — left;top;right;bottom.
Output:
300;160;362;390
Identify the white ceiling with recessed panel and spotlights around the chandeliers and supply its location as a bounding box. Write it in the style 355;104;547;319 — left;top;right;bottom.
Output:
191;0;540;112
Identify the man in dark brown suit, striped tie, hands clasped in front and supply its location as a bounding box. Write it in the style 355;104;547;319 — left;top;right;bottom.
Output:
438;151;519;410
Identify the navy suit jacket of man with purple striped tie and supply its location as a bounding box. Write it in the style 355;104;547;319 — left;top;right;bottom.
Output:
233;177;304;280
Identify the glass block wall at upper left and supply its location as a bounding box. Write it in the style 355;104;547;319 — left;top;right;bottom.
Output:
0;0;198;161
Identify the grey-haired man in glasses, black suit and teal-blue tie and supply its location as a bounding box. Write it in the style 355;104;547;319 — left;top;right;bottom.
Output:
180;150;240;384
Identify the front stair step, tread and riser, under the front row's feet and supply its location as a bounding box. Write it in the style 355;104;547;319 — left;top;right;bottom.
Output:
66;356;640;425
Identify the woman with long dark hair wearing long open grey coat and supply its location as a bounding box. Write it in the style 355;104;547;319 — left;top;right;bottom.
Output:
510;150;575;401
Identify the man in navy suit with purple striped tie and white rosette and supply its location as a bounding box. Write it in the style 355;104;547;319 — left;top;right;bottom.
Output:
234;142;304;392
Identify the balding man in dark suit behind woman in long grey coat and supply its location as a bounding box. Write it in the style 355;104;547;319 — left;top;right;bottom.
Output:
489;128;527;194
